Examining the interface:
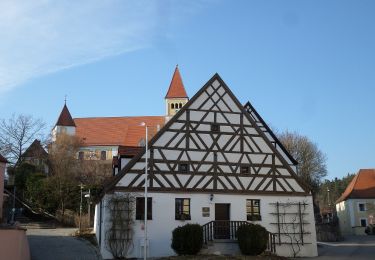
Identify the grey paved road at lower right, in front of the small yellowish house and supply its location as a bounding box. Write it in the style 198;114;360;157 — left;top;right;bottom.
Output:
304;236;375;260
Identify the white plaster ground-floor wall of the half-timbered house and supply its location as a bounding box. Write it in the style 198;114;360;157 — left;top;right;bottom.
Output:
101;193;317;259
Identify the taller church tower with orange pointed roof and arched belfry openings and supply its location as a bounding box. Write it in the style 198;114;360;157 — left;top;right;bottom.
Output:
165;65;189;118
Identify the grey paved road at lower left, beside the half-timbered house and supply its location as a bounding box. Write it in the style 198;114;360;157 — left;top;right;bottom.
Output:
27;228;101;260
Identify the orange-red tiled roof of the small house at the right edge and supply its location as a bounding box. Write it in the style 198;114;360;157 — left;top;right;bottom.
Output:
336;169;375;203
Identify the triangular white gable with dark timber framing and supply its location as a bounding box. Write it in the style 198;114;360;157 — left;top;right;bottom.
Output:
106;74;309;195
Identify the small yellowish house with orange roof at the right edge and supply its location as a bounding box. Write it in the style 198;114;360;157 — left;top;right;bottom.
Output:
336;169;375;235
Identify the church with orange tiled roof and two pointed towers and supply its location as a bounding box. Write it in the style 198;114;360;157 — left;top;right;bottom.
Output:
52;67;189;179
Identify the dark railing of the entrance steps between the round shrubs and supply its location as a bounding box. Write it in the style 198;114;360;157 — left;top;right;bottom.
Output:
202;220;276;253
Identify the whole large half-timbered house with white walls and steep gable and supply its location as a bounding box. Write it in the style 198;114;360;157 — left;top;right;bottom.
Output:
94;74;317;259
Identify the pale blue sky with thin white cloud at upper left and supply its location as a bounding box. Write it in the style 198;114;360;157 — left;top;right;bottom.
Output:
0;0;375;178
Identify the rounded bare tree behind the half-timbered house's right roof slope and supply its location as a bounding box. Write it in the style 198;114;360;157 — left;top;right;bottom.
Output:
278;131;327;193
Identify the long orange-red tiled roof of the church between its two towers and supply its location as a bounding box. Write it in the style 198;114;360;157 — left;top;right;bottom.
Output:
74;116;165;146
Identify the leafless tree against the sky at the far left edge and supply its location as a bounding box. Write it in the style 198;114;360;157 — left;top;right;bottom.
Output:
0;114;45;165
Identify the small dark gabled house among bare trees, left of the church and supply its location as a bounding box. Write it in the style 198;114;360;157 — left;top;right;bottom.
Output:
20;139;48;174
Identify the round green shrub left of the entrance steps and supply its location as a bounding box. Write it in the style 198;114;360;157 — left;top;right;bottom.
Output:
171;224;203;255
